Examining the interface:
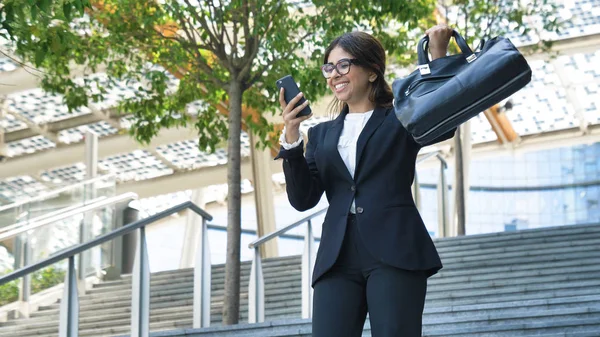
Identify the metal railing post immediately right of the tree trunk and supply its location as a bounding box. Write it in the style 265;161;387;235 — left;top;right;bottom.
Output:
248;246;265;323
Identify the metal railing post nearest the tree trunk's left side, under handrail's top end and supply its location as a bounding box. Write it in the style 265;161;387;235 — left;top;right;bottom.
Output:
193;217;211;329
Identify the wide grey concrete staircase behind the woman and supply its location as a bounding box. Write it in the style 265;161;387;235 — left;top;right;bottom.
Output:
0;225;600;337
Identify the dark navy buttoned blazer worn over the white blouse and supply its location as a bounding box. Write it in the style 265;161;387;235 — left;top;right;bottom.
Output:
276;108;454;285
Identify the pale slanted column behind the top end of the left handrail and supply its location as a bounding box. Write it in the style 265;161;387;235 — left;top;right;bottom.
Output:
179;188;206;269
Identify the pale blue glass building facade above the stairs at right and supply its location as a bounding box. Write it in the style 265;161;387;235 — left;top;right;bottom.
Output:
418;143;600;236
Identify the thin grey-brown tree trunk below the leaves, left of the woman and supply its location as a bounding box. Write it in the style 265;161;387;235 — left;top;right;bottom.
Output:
223;80;242;325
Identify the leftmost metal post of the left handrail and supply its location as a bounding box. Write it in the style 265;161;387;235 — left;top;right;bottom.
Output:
58;256;79;337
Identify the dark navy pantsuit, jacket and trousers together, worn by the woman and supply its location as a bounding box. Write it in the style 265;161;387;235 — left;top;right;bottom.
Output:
277;103;454;337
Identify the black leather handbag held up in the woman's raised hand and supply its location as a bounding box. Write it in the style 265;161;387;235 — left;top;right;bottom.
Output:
392;31;531;145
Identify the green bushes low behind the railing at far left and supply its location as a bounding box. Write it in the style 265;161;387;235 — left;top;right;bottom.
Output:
0;266;65;306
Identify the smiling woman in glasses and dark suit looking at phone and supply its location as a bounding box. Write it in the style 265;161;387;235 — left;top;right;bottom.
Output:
277;25;454;337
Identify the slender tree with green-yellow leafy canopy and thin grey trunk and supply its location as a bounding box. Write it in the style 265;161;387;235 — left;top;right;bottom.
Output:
3;0;440;324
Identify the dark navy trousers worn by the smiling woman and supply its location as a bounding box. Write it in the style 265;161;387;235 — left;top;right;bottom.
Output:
312;215;427;337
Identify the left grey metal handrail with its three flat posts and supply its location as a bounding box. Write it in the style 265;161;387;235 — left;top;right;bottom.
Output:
0;201;213;337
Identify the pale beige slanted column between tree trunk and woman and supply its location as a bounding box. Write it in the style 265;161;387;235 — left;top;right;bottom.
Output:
250;134;279;258
